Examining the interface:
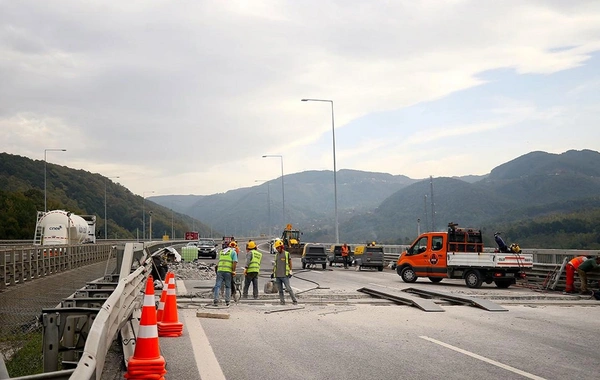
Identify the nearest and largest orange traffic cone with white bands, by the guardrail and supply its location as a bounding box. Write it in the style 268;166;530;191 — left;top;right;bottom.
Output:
125;276;167;380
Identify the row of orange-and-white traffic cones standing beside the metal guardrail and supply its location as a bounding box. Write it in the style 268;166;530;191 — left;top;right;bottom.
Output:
125;272;183;380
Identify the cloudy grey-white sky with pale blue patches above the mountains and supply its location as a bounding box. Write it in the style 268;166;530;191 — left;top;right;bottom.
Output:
0;0;600;196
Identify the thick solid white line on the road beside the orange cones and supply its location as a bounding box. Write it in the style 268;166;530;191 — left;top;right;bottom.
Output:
182;310;225;380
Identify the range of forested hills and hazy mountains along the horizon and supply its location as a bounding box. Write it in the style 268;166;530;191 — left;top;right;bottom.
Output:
0;150;600;249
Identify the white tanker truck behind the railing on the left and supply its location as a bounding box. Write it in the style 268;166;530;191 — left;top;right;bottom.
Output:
33;210;96;245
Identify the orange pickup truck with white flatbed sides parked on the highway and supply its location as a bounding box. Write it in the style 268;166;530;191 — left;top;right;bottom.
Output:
396;223;533;288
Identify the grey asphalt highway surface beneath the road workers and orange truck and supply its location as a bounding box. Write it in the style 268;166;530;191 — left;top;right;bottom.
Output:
151;248;600;380
